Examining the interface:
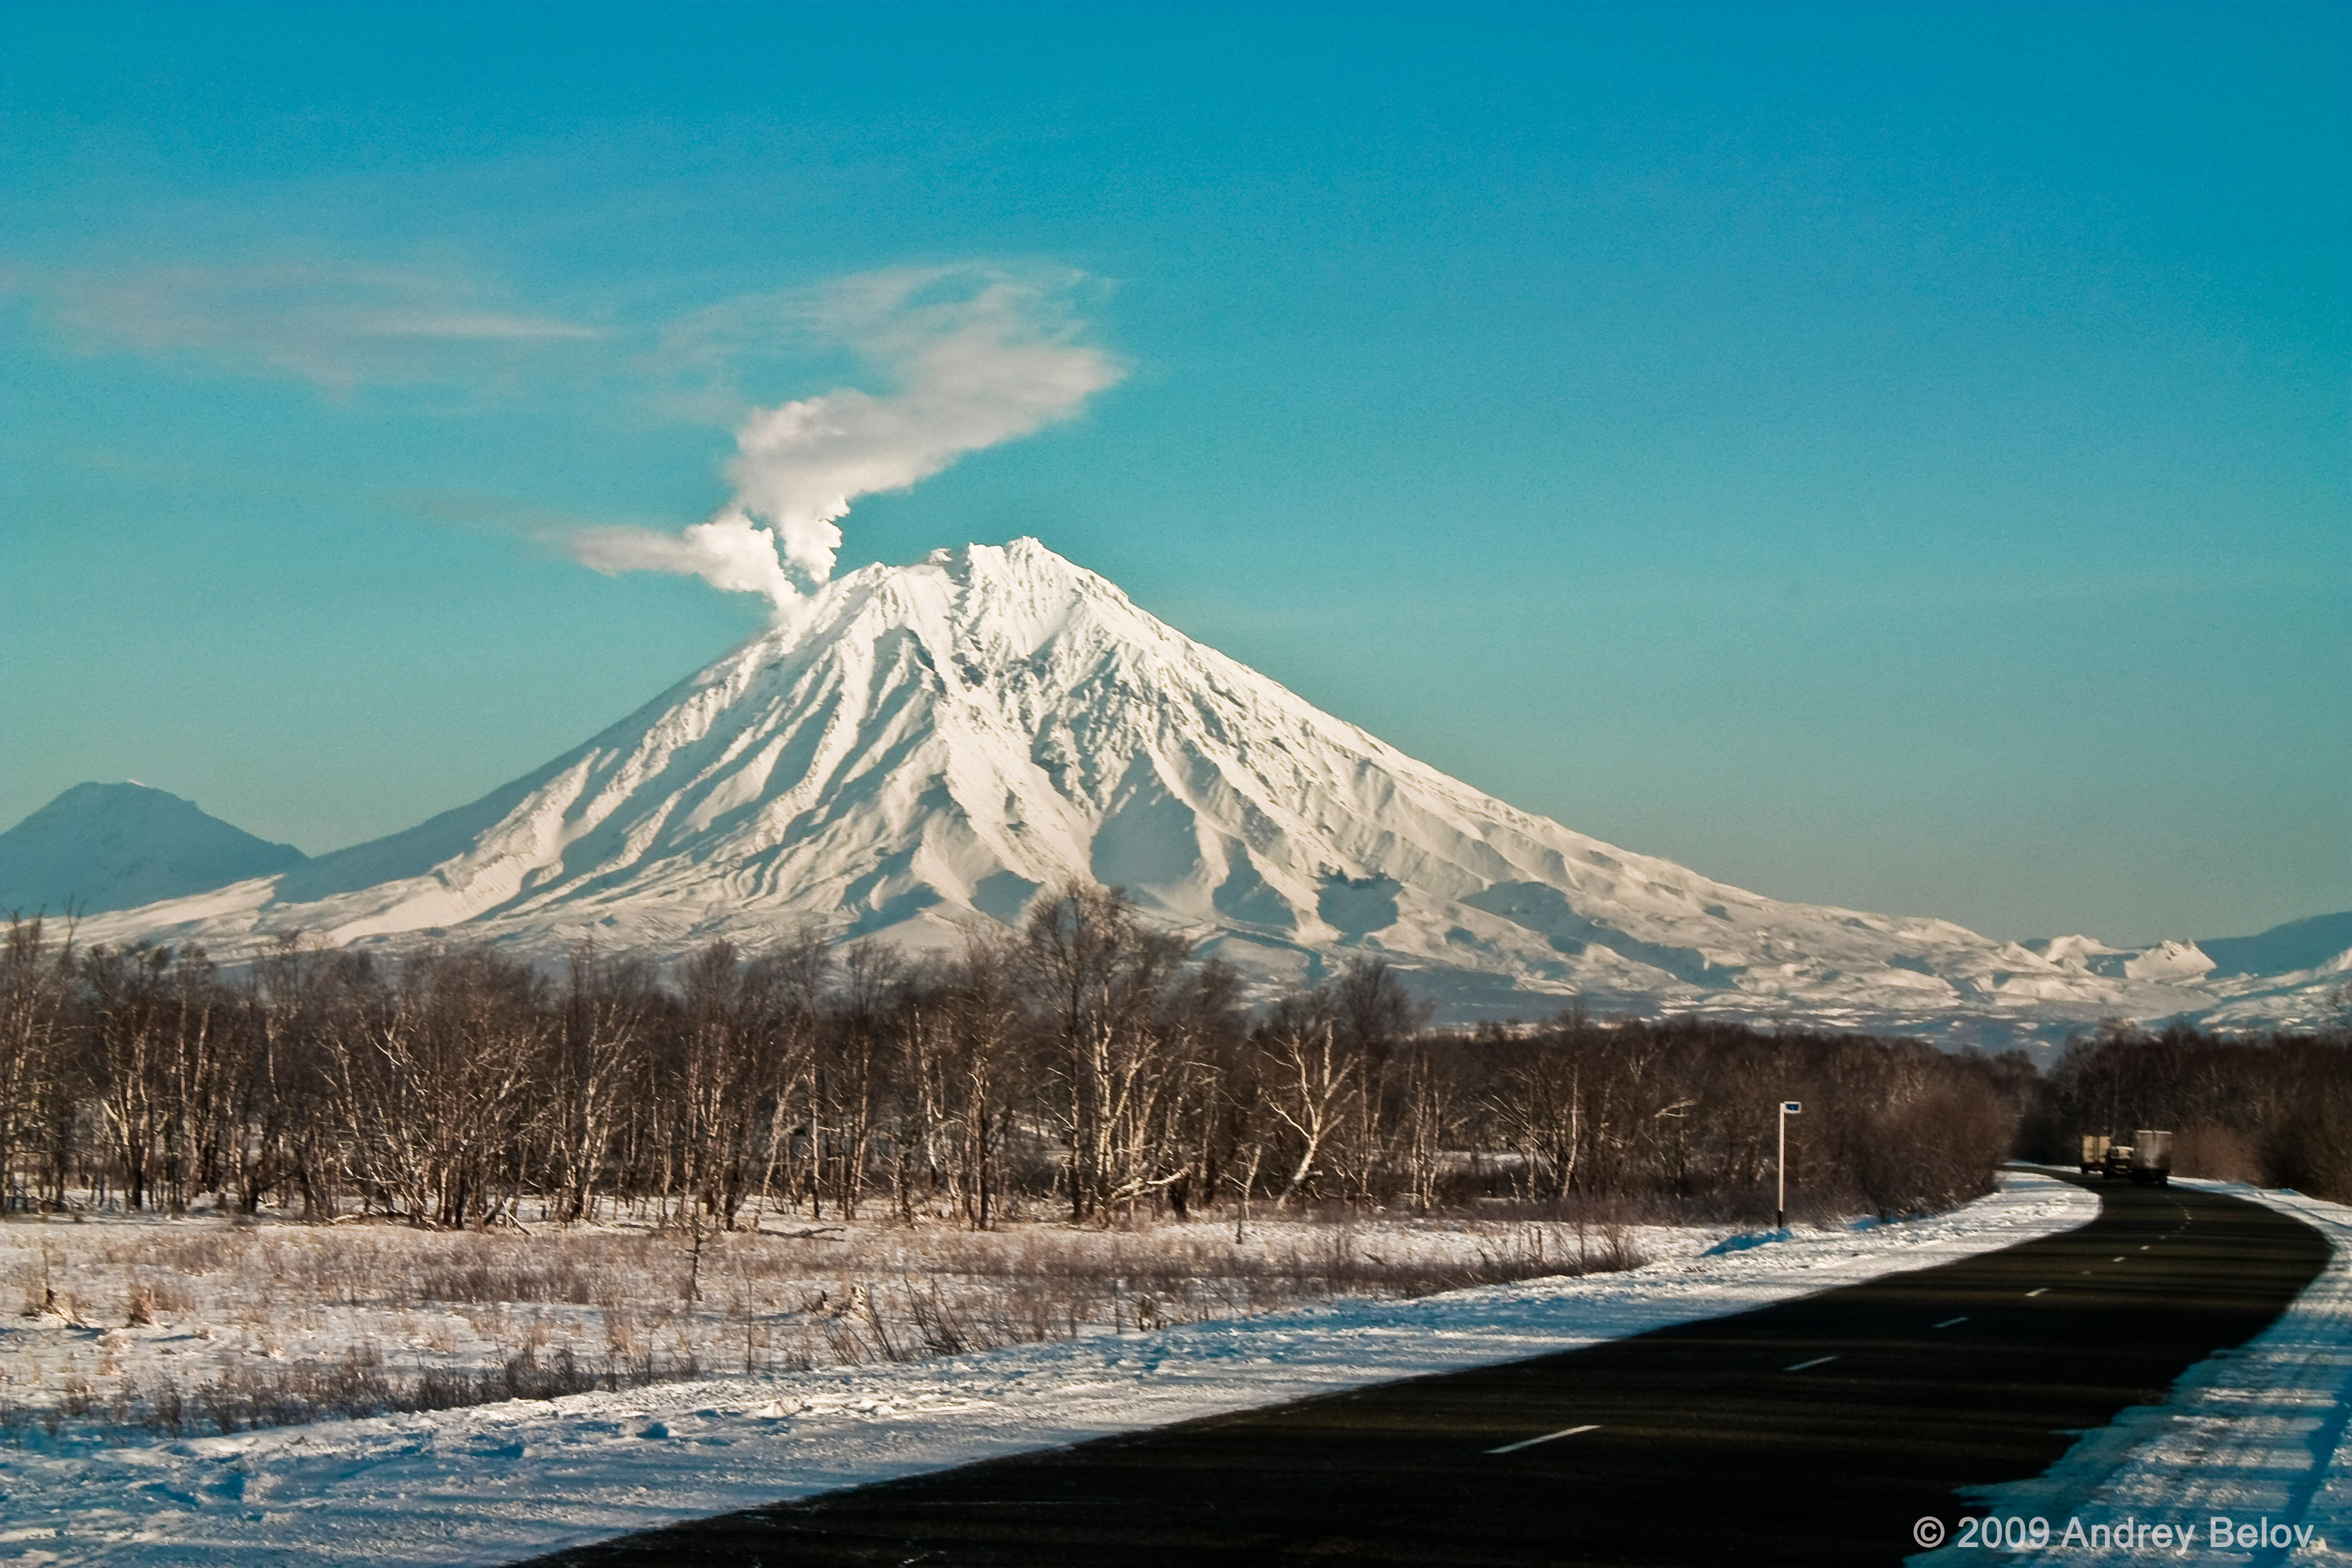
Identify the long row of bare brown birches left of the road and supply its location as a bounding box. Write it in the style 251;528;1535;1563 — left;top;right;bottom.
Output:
0;884;2220;1234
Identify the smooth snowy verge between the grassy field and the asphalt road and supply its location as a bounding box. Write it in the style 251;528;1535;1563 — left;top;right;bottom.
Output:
0;1170;2098;1563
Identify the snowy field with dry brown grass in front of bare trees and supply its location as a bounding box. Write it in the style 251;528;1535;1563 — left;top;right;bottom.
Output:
0;1204;1656;1453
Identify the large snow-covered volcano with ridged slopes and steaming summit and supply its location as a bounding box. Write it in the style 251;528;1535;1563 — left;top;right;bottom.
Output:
73;538;2333;1032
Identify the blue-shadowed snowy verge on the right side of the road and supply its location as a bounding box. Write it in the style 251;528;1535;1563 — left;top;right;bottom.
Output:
1910;1178;2352;1568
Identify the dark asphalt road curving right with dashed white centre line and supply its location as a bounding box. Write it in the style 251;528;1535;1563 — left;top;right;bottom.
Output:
538;1180;2328;1568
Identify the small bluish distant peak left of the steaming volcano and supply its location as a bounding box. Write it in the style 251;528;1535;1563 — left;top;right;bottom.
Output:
0;783;303;914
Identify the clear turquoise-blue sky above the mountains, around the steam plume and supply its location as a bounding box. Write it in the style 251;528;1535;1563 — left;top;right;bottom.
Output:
0;5;2352;940
